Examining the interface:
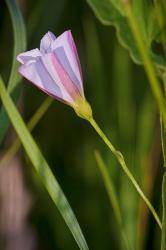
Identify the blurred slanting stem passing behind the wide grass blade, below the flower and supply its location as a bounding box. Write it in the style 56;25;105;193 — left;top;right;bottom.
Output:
0;97;53;166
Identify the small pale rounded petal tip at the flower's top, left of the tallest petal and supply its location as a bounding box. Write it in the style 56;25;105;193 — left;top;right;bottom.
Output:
40;31;56;53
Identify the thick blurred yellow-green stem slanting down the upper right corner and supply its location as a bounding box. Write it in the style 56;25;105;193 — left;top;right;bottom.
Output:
123;0;166;124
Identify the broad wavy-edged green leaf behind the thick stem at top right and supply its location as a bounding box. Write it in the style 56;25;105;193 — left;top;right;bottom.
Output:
87;0;163;64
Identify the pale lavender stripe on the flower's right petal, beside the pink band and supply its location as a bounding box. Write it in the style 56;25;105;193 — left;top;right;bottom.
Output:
54;47;84;96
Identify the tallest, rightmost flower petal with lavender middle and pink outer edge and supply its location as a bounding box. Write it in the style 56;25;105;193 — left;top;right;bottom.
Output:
51;31;84;97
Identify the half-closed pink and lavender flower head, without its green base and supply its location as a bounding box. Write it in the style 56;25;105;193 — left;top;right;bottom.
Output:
17;31;84;106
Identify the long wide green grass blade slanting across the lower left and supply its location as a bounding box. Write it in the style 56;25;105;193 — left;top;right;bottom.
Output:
0;78;88;250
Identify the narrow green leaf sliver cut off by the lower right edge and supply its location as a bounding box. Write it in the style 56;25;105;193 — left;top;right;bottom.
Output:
161;173;166;250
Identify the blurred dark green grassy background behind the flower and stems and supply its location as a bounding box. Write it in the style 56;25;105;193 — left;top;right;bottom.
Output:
0;0;162;250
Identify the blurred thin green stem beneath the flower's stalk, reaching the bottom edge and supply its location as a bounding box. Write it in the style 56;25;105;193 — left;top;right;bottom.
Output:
95;151;131;250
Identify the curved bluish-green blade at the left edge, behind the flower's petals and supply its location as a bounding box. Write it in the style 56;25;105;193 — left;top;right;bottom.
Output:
0;0;26;143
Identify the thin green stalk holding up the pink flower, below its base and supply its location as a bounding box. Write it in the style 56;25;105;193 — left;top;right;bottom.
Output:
88;118;162;229
